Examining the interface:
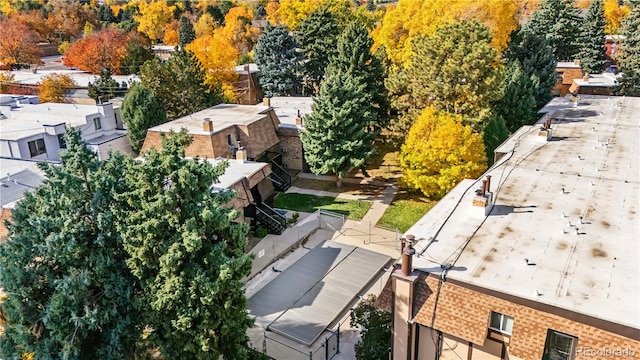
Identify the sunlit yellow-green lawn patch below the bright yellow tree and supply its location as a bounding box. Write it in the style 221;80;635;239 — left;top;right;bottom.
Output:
378;190;437;232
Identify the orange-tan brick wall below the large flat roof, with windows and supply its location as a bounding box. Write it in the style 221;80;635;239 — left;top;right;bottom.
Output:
415;276;640;359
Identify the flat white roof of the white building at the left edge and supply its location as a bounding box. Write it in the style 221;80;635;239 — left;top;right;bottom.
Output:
0;103;100;140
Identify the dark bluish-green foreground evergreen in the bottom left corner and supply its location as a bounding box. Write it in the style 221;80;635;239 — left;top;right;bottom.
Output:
0;129;143;360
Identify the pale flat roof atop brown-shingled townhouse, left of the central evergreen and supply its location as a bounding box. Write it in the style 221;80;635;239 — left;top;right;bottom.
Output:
149;104;269;135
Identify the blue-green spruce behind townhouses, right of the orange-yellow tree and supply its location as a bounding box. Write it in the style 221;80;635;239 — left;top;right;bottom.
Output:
254;25;301;97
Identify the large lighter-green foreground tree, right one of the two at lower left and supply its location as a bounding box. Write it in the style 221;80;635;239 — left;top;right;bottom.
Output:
117;131;252;359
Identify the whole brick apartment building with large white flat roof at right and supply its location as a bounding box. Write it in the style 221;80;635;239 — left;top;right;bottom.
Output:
379;96;640;360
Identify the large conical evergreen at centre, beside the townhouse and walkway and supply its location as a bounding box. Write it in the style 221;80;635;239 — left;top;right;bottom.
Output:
300;68;377;186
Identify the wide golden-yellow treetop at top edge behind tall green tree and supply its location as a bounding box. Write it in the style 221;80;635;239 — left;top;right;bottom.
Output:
372;0;519;65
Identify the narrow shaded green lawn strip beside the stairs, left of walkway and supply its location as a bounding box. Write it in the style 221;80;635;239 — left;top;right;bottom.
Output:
273;193;371;220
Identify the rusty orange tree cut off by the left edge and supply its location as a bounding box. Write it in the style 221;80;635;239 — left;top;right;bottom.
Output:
0;19;42;65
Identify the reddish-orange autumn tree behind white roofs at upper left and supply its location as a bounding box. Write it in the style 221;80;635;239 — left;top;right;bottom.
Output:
64;27;130;74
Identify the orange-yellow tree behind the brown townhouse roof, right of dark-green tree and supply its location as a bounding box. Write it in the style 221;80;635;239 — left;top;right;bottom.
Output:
186;30;238;101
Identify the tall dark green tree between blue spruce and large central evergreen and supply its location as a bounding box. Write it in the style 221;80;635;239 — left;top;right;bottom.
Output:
296;6;340;95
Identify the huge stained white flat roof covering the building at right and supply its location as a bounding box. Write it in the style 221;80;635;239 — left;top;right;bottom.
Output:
407;95;640;328
